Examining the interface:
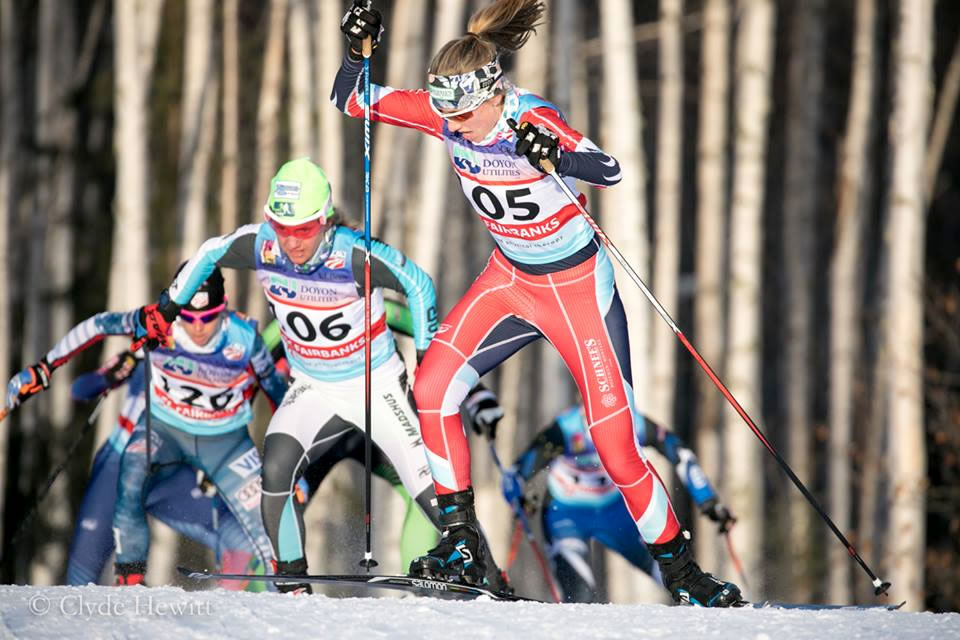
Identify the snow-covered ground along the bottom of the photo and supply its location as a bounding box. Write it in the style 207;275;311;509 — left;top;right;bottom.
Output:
0;586;960;640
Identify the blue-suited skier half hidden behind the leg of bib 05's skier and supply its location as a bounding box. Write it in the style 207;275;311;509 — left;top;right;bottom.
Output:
502;405;736;602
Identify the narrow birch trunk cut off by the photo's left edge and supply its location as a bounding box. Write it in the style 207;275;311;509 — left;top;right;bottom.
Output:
0;0;23;556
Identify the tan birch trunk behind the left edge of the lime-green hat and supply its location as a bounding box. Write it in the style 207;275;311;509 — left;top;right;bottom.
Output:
244;0;288;322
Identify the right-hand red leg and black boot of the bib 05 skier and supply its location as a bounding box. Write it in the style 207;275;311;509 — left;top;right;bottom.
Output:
537;253;741;607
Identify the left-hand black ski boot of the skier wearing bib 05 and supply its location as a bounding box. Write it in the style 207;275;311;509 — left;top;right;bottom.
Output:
410;487;489;586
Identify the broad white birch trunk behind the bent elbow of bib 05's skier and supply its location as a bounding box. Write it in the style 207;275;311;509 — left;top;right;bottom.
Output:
600;0;662;602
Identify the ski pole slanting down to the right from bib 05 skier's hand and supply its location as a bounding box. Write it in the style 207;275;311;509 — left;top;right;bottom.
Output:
507;119;890;595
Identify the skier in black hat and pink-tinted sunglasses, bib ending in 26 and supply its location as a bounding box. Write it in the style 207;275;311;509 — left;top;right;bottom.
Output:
8;270;286;584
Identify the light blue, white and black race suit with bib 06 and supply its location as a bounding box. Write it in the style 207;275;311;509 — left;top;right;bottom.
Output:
168;223;437;571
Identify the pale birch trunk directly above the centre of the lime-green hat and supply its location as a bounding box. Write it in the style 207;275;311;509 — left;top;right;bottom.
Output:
287;0;315;158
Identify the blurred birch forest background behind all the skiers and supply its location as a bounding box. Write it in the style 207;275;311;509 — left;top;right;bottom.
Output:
0;0;960;610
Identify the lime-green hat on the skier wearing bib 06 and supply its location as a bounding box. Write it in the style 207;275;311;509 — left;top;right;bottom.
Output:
263;158;333;226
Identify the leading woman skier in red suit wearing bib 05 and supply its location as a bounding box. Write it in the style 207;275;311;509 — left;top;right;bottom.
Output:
331;0;741;606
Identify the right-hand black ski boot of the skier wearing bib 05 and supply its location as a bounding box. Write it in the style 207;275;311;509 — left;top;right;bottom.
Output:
647;531;743;607
